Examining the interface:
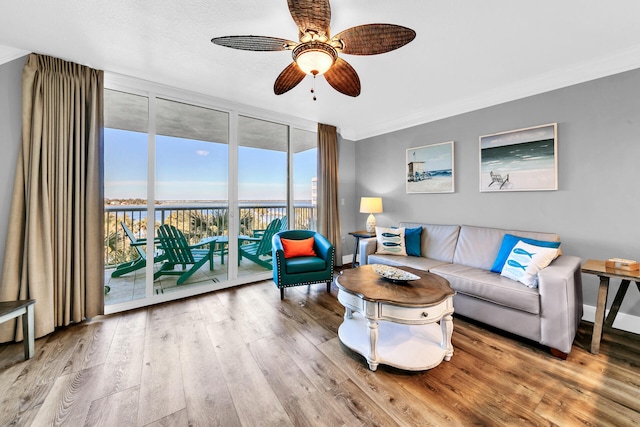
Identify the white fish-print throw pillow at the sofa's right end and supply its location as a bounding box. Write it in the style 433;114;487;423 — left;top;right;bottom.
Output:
501;241;558;288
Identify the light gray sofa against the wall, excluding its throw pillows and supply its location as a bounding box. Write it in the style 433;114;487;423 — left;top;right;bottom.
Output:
359;222;582;359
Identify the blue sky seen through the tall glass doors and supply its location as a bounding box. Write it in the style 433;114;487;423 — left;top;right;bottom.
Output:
104;128;317;201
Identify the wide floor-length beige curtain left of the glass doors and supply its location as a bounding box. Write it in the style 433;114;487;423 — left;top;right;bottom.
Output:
0;54;104;342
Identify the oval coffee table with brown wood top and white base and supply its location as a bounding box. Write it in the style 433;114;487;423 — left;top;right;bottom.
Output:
335;265;455;371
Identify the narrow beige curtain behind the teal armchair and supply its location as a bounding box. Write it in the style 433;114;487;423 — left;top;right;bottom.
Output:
318;123;342;266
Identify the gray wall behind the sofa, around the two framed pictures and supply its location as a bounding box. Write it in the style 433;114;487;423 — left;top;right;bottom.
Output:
355;70;640;317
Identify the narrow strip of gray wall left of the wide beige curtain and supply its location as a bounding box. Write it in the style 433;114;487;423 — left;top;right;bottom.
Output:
0;56;27;275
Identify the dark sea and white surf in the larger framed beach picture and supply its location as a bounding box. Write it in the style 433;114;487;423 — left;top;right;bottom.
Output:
481;139;555;173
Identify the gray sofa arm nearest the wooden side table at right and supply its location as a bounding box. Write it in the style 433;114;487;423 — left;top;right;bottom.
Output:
538;255;582;354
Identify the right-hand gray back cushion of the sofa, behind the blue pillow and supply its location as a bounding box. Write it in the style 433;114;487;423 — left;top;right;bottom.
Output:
453;225;560;270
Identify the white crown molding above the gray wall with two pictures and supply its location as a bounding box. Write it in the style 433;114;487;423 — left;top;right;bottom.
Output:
342;45;640;141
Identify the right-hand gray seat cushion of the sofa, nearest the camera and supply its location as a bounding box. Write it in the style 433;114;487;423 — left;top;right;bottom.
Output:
429;264;540;314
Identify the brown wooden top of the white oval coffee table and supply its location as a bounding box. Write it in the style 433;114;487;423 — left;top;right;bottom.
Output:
336;265;455;307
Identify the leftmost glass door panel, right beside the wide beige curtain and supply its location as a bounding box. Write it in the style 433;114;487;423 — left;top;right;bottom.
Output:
104;90;153;305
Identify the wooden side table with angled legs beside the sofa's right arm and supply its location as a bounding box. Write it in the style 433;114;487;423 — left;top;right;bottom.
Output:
582;259;640;354
